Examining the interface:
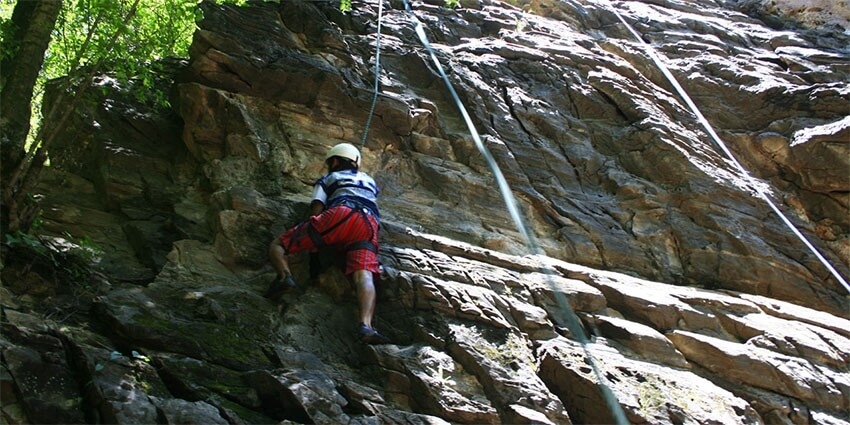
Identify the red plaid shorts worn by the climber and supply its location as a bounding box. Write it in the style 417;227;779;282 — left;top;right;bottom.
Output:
280;205;379;276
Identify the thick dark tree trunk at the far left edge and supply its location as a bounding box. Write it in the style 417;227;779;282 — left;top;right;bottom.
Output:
0;0;62;232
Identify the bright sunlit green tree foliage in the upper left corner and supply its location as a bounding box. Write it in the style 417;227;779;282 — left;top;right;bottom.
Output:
0;0;244;235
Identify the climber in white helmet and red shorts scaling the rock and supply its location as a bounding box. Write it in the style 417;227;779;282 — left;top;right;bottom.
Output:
265;143;389;344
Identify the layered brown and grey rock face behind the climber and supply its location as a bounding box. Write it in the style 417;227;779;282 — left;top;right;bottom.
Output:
0;0;850;424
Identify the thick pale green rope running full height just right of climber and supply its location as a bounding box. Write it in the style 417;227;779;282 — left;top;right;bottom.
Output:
394;0;629;425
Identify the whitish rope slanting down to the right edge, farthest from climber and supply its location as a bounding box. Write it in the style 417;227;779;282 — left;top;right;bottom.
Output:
609;0;850;292
